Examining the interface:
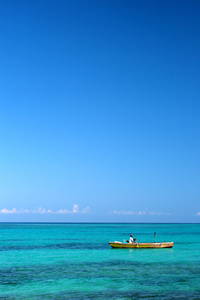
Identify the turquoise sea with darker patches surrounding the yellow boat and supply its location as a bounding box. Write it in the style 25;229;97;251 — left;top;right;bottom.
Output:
0;223;200;299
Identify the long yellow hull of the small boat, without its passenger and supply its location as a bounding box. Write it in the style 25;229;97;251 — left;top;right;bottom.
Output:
109;242;173;249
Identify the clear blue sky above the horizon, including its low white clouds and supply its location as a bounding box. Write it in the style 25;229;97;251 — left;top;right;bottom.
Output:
0;0;200;223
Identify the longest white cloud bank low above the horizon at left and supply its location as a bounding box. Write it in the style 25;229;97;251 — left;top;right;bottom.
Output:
0;204;90;214
